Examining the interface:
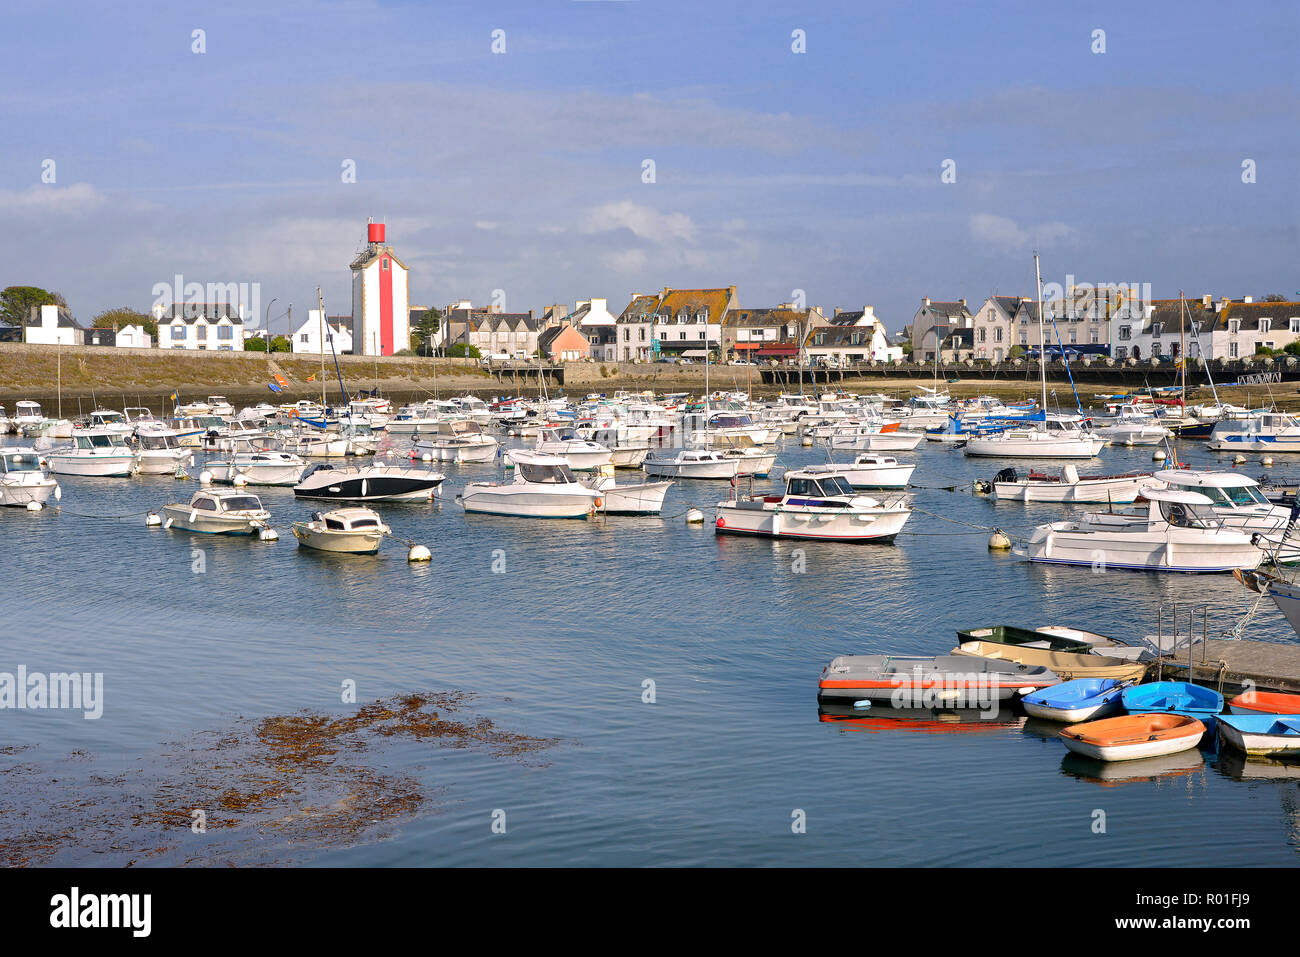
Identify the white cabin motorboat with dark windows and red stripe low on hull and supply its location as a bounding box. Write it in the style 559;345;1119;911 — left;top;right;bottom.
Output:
714;465;911;542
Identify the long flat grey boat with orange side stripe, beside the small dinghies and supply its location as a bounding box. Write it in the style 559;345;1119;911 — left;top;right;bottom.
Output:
818;654;1061;707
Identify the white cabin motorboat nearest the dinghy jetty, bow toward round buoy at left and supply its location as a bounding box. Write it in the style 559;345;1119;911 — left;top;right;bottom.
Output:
1013;489;1265;572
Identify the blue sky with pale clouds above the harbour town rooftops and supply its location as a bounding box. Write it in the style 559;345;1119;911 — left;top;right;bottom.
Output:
0;0;1300;329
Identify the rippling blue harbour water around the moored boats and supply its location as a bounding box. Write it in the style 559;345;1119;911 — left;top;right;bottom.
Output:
0;429;1300;866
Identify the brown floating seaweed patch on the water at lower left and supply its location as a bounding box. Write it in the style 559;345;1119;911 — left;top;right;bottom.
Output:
0;692;556;866
